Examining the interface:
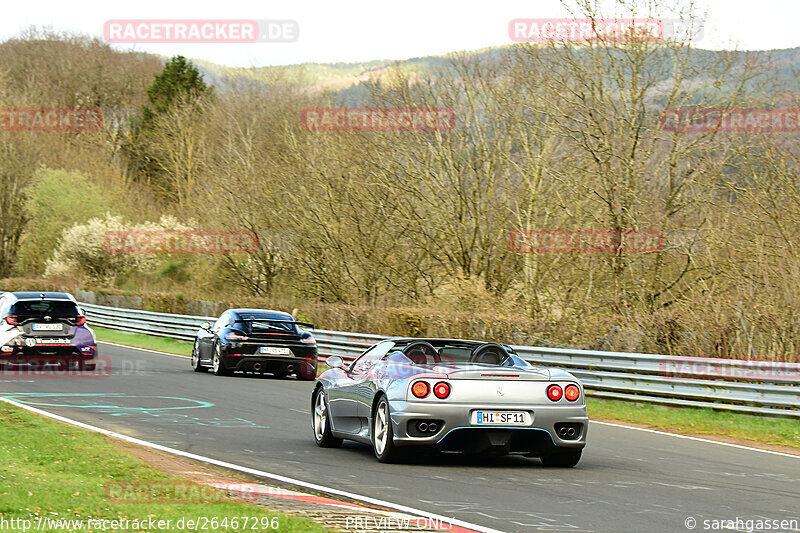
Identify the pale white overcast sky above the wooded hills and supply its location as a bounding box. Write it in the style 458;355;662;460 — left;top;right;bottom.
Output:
0;0;800;67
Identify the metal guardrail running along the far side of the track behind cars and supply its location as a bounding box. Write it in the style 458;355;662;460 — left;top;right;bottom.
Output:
80;304;800;418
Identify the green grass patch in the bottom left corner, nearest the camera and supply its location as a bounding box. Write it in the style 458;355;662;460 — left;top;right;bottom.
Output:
0;402;326;532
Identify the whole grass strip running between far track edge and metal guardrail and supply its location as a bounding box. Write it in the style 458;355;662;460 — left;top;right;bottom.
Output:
93;327;800;449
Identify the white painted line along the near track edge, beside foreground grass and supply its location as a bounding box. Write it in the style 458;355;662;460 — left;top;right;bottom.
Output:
0;394;503;533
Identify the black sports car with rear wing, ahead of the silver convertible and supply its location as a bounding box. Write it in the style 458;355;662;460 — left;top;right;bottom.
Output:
192;309;317;381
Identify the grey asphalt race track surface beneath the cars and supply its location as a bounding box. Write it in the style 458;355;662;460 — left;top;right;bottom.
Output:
0;343;800;532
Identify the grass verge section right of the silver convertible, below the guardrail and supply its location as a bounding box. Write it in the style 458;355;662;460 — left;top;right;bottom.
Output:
586;397;800;449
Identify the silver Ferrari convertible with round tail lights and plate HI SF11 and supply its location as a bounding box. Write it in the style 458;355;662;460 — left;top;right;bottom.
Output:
311;338;588;467
